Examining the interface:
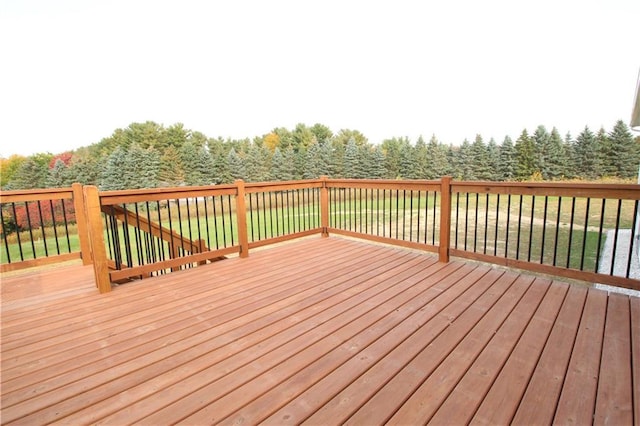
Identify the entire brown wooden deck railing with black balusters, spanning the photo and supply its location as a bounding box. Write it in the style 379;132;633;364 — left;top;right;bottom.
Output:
2;177;640;292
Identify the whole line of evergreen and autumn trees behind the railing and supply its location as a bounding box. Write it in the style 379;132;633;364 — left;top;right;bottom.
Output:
0;120;640;190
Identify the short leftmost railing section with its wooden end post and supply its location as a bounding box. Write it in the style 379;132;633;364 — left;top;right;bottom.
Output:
0;184;91;272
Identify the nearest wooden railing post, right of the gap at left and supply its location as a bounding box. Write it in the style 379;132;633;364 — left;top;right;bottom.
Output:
83;186;111;293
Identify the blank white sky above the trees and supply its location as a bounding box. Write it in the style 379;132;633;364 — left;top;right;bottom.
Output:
0;0;640;157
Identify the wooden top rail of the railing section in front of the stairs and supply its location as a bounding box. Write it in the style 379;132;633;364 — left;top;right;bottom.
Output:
100;185;238;206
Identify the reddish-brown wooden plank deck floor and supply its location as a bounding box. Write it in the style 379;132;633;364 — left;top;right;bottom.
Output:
1;238;640;425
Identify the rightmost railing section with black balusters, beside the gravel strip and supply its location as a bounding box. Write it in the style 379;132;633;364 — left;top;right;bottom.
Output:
450;182;640;290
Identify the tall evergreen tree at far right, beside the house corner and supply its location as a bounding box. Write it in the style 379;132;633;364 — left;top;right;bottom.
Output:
605;120;640;179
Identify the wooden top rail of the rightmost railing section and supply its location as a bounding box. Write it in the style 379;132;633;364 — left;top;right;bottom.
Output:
451;181;640;200
